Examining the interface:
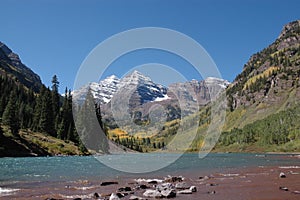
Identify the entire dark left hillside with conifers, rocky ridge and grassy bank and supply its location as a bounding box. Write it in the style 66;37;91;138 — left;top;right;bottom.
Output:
0;43;86;156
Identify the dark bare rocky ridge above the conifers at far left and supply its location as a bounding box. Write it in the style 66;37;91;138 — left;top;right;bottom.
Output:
0;42;42;92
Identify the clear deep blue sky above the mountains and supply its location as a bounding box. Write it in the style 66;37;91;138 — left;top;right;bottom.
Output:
0;0;300;91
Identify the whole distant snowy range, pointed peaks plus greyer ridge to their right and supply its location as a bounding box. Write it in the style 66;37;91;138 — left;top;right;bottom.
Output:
73;70;230;106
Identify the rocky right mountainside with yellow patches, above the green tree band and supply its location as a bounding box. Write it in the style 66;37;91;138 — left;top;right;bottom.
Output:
226;20;300;130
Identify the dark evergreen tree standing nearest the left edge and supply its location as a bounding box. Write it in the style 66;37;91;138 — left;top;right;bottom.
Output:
2;91;20;136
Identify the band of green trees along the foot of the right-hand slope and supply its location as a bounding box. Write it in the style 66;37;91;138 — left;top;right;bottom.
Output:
219;106;300;146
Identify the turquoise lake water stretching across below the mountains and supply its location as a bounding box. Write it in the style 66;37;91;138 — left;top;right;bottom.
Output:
0;153;300;184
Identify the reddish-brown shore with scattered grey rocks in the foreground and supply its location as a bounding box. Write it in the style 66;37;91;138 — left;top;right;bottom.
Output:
1;166;300;200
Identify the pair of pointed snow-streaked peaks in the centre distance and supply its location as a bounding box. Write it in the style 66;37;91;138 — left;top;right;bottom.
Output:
73;71;167;106
